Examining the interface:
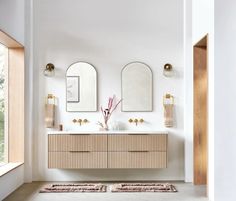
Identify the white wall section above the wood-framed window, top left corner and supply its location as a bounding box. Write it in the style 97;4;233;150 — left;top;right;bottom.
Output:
0;0;25;45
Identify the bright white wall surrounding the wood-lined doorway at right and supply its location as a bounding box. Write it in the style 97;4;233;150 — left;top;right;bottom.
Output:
185;0;214;200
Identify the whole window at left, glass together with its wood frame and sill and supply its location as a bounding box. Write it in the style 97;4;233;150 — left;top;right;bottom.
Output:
0;30;25;177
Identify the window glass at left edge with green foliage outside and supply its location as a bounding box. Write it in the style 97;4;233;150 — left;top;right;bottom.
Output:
0;44;8;166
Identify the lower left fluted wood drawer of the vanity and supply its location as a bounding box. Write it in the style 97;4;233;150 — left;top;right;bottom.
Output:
48;152;107;169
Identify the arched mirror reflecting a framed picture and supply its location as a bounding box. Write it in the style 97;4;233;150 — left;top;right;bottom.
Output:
66;62;97;112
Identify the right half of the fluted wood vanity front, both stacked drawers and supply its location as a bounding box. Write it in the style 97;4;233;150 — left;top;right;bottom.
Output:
108;134;167;168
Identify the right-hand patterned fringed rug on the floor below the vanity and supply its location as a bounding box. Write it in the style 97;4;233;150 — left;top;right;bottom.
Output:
111;183;177;192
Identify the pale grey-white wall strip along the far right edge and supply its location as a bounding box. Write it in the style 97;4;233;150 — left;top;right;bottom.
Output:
215;0;236;201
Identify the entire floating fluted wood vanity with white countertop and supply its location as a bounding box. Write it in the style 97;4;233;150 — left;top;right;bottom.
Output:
48;131;168;169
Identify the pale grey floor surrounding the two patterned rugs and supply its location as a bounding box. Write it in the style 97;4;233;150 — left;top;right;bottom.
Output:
4;182;208;201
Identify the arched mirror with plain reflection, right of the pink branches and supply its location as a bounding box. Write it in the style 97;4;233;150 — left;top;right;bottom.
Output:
121;62;152;112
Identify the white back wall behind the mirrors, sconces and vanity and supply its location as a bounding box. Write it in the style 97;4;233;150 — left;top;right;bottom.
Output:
33;0;185;180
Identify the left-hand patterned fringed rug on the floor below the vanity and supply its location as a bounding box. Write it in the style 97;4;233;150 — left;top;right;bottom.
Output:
39;183;107;193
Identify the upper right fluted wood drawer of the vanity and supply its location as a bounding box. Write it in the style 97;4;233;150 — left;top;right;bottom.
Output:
108;134;168;151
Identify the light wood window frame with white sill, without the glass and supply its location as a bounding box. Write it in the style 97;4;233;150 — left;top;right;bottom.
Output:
0;29;25;177
